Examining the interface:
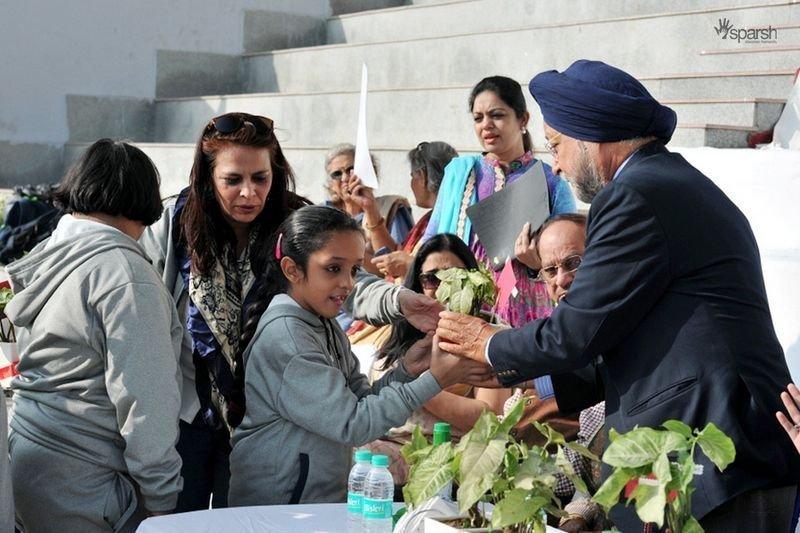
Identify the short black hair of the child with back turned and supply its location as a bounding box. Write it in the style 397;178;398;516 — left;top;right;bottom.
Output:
53;139;163;226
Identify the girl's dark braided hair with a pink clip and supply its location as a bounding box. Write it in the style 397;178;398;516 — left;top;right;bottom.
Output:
240;205;363;351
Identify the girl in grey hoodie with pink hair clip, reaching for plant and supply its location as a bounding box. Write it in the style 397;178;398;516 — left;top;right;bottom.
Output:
228;206;487;506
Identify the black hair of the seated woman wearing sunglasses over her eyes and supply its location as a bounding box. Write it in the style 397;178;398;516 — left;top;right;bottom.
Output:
376;233;478;369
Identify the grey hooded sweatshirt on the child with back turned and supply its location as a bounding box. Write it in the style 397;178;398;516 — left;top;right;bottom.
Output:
6;215;182;518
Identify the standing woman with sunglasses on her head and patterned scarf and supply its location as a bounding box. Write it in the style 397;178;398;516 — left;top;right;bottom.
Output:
141;113;308;512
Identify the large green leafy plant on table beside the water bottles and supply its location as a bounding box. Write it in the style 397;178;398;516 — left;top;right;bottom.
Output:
402;401;598;533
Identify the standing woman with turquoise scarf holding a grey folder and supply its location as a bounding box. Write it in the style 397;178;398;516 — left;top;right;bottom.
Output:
424;76;576;327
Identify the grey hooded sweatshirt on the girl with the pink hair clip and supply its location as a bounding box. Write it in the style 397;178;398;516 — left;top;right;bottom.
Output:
228;294;441;506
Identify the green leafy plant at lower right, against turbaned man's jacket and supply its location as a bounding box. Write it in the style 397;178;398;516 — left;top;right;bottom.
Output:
593;420;736;533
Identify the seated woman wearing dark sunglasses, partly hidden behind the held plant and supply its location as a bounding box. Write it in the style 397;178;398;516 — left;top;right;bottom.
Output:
368;233;512;487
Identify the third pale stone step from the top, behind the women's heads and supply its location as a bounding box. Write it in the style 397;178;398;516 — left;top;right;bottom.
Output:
147;87;783;148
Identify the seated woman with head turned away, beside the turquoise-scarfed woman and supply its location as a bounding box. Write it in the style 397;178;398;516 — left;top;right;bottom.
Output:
372;141;458;278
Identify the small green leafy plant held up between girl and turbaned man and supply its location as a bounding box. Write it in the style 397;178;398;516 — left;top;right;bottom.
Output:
436;263;497;316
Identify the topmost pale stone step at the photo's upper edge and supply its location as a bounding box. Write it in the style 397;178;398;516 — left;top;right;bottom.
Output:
326;0;786;44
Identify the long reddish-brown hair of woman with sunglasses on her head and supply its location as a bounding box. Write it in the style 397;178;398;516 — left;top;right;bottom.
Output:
180;113;310;275
